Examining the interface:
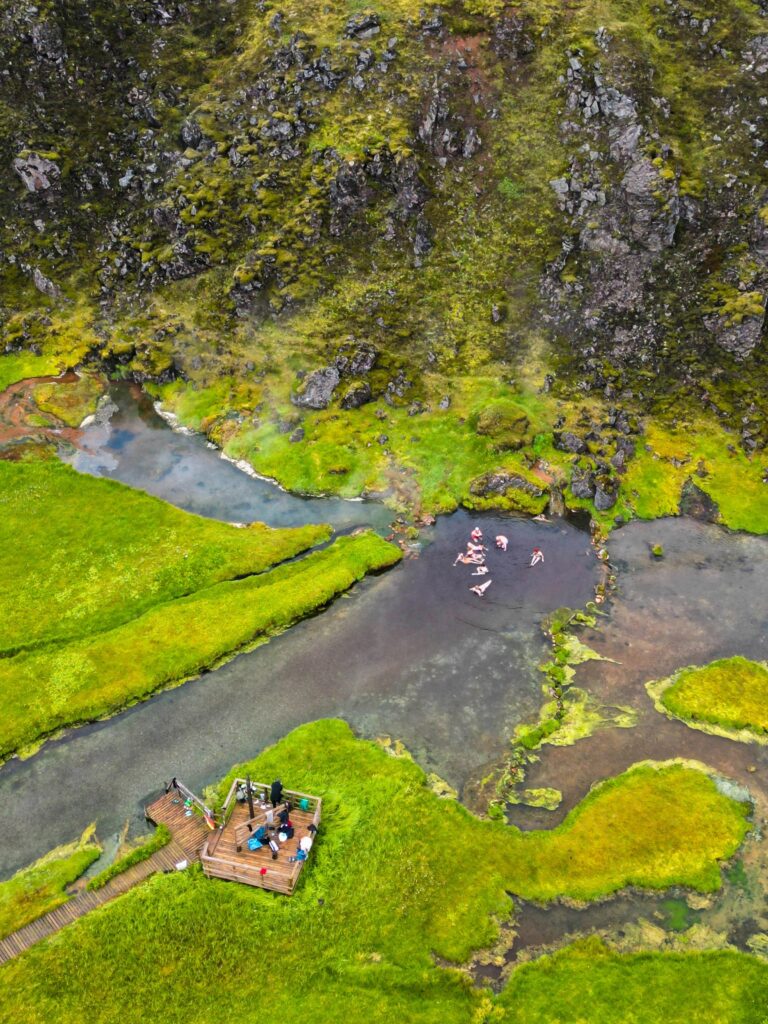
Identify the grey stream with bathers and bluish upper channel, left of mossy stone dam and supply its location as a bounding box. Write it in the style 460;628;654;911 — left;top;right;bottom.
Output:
0;390;600;874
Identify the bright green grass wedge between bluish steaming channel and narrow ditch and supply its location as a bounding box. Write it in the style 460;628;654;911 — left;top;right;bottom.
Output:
0;462;330;652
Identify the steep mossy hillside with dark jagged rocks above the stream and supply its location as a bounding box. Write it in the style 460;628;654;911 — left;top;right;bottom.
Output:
0;0;768;524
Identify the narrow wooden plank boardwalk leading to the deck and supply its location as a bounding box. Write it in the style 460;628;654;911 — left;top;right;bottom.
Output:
0;825;188;964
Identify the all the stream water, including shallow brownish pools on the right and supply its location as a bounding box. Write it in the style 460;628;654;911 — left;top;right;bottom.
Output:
0;388;768;966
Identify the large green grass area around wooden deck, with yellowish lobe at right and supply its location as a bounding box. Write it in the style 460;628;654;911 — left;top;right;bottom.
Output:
0;721;746;1024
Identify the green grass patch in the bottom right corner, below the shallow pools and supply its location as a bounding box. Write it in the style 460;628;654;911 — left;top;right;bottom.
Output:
499;938;768;1024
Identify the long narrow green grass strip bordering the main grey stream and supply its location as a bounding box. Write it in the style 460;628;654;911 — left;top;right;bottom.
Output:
0;532;400;758
